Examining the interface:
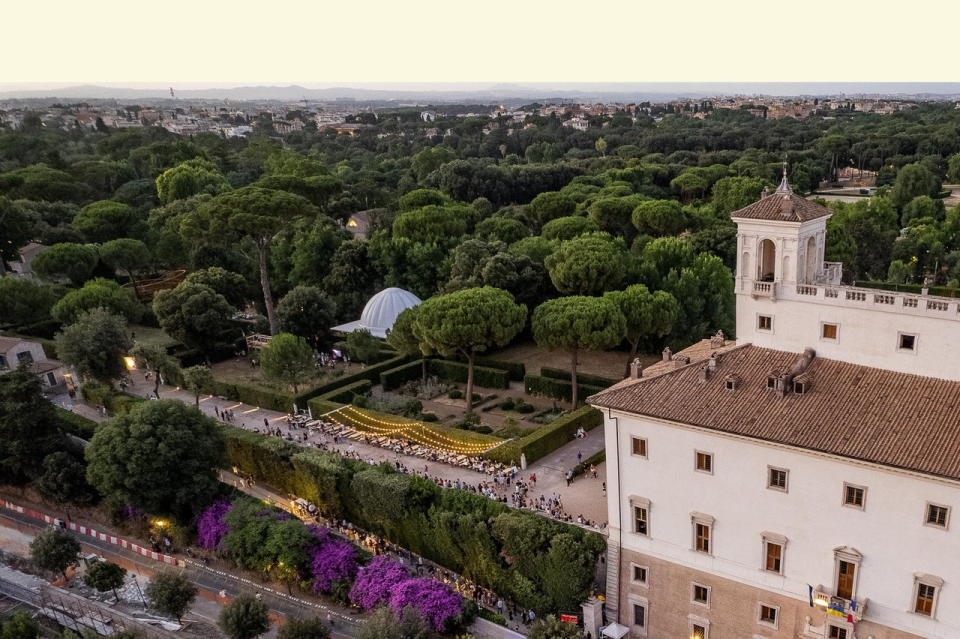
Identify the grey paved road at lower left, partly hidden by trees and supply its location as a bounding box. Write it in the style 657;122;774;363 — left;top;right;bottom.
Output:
0;509;360;639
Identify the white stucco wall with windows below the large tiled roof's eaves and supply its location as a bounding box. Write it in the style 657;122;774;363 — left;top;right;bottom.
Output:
604;410;960;639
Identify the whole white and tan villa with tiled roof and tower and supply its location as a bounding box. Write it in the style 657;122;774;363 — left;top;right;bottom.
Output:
588;171;960;639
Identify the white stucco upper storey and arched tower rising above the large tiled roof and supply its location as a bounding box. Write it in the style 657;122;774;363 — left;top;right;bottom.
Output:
734;217;960;380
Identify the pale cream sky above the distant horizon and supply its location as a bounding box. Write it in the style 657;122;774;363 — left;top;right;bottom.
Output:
0;0;960;86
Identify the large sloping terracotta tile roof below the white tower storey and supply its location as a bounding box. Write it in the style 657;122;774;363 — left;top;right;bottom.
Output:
588;344;960;479
